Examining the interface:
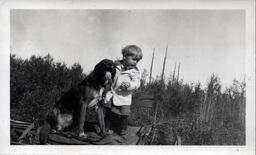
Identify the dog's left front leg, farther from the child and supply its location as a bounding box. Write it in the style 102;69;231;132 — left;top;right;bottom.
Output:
79;99;88;139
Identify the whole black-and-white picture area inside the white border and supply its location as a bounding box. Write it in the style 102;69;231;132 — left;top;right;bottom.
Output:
10;9;249;145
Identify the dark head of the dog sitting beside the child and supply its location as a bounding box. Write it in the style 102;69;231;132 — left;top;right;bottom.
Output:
93;59;116;87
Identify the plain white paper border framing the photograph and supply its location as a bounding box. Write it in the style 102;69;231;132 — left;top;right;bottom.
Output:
0;0;255;155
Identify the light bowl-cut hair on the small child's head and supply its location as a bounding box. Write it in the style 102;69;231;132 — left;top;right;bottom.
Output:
122;45;143;61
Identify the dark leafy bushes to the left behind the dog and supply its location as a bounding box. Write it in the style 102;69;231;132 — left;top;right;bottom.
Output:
10;54;85;121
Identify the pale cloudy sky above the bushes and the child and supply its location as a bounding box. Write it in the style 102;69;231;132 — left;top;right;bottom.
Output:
10;10;245;86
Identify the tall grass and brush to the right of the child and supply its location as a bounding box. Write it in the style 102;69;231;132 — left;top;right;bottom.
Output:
130;74;245;145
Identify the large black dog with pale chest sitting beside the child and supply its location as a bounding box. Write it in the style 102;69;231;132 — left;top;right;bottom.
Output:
39;59;116;144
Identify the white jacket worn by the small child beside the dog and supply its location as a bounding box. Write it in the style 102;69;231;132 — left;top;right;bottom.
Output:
112;65;141;106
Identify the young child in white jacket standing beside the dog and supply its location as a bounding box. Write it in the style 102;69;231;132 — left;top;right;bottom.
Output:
105;45;143;136
